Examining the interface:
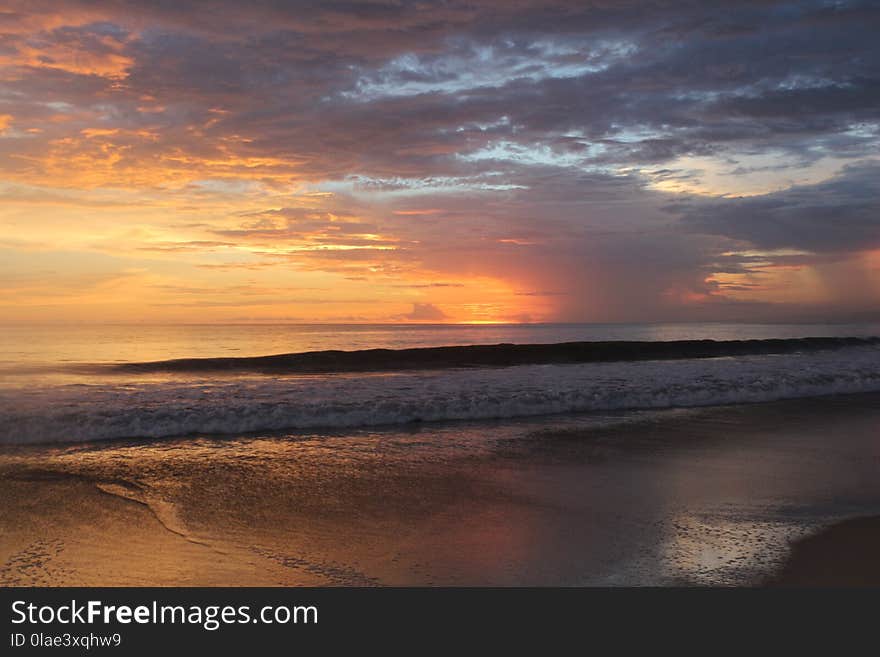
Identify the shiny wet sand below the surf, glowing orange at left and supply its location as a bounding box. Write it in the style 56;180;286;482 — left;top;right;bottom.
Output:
0;394;880;586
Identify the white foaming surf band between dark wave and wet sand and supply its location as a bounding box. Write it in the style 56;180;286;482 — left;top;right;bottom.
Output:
0;347;880;444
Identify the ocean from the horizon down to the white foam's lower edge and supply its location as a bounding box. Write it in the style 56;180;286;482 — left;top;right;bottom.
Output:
0;324;880;444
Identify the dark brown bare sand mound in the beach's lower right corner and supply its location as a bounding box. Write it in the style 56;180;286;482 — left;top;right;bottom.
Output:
763;516;880;588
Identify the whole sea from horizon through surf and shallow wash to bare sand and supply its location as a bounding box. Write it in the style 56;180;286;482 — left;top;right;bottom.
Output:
0;324;880;586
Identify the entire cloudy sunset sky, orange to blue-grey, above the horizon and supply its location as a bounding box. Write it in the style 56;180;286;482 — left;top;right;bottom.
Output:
0;0;880;323
